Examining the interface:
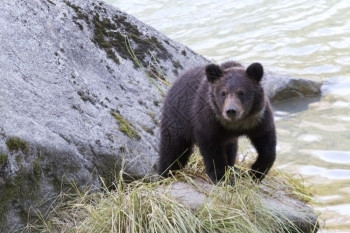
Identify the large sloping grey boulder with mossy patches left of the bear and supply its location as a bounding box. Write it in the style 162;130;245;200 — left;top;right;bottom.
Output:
0;0;322;232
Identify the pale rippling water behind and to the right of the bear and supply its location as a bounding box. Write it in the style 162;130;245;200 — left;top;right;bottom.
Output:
107;0;350;233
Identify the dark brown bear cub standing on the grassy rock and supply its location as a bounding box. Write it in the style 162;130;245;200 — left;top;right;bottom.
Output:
158;62;276;183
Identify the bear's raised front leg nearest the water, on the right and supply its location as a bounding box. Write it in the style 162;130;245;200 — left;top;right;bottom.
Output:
249;129;276;181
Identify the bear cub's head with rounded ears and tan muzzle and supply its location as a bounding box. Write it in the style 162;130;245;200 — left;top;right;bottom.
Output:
205;63;266;126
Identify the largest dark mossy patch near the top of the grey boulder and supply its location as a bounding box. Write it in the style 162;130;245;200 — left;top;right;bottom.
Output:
65;0;173;84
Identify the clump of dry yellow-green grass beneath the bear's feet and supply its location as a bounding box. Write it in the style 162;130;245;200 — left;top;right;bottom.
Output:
26;147;316;233
